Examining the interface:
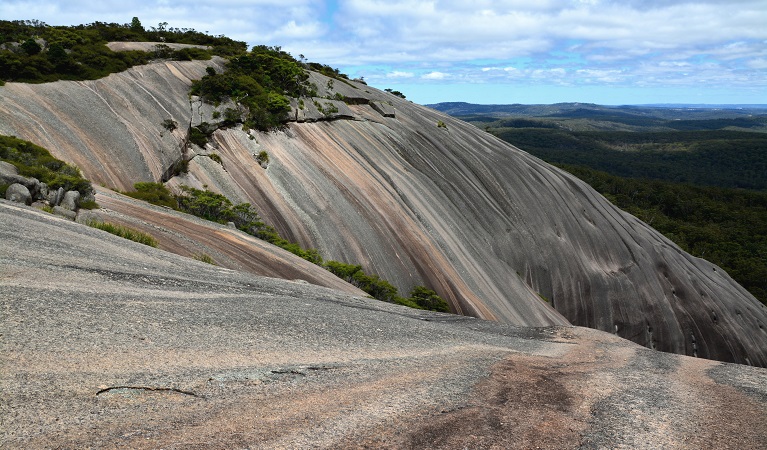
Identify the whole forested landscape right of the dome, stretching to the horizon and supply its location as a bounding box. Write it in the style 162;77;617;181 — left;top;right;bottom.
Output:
432;103;767;304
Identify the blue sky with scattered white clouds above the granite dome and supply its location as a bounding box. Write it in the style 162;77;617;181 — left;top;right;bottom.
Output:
0;0;767;104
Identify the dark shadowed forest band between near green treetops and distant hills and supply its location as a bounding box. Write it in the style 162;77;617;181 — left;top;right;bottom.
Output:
491;127;767;191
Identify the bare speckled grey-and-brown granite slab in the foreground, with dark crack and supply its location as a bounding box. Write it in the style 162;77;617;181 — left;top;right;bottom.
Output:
0;200;767;449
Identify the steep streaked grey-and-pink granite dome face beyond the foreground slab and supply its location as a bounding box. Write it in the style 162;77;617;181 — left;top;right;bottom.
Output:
0;60;767;366
